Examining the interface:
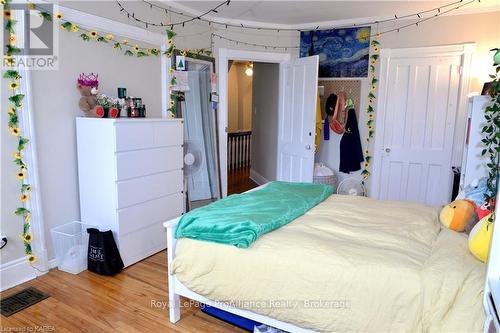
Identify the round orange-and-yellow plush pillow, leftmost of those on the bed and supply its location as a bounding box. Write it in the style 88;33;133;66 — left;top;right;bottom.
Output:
439;199;478;232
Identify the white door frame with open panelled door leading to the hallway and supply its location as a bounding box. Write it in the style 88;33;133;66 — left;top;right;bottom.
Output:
217;48;319;196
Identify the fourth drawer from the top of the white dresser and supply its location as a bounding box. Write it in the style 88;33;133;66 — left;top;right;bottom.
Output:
118;193;184;236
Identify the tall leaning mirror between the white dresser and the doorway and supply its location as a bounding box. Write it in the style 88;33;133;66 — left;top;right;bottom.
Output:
172;50;222;211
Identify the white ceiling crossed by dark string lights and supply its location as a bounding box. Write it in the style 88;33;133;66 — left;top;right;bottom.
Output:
57;0;500;36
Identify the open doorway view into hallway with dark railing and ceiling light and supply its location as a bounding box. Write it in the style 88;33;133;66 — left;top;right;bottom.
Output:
227;60;279;195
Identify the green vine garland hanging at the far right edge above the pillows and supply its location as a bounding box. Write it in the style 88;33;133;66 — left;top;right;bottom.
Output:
481;48;500;223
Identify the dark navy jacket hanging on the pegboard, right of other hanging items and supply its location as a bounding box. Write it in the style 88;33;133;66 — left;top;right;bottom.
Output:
339;109;364;173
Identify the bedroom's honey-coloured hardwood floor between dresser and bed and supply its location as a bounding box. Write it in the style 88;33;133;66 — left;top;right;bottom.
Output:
0;252;245;333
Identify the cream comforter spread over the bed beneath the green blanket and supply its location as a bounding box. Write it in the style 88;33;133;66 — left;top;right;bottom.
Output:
173;195;485;332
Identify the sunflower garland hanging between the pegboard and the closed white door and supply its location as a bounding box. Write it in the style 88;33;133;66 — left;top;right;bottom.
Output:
361;39;380;184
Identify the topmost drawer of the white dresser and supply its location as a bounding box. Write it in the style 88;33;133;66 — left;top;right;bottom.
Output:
115;121;183;152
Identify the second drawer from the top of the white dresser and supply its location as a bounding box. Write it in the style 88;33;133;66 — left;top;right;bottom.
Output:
116;146;182;180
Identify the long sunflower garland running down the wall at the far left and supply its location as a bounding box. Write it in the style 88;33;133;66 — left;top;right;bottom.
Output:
3;0;37;264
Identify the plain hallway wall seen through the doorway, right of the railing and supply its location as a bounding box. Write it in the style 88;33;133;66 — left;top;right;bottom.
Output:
251;63;279;183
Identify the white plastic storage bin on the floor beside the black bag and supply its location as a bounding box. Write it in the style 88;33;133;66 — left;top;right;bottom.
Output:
50;221;95;274
